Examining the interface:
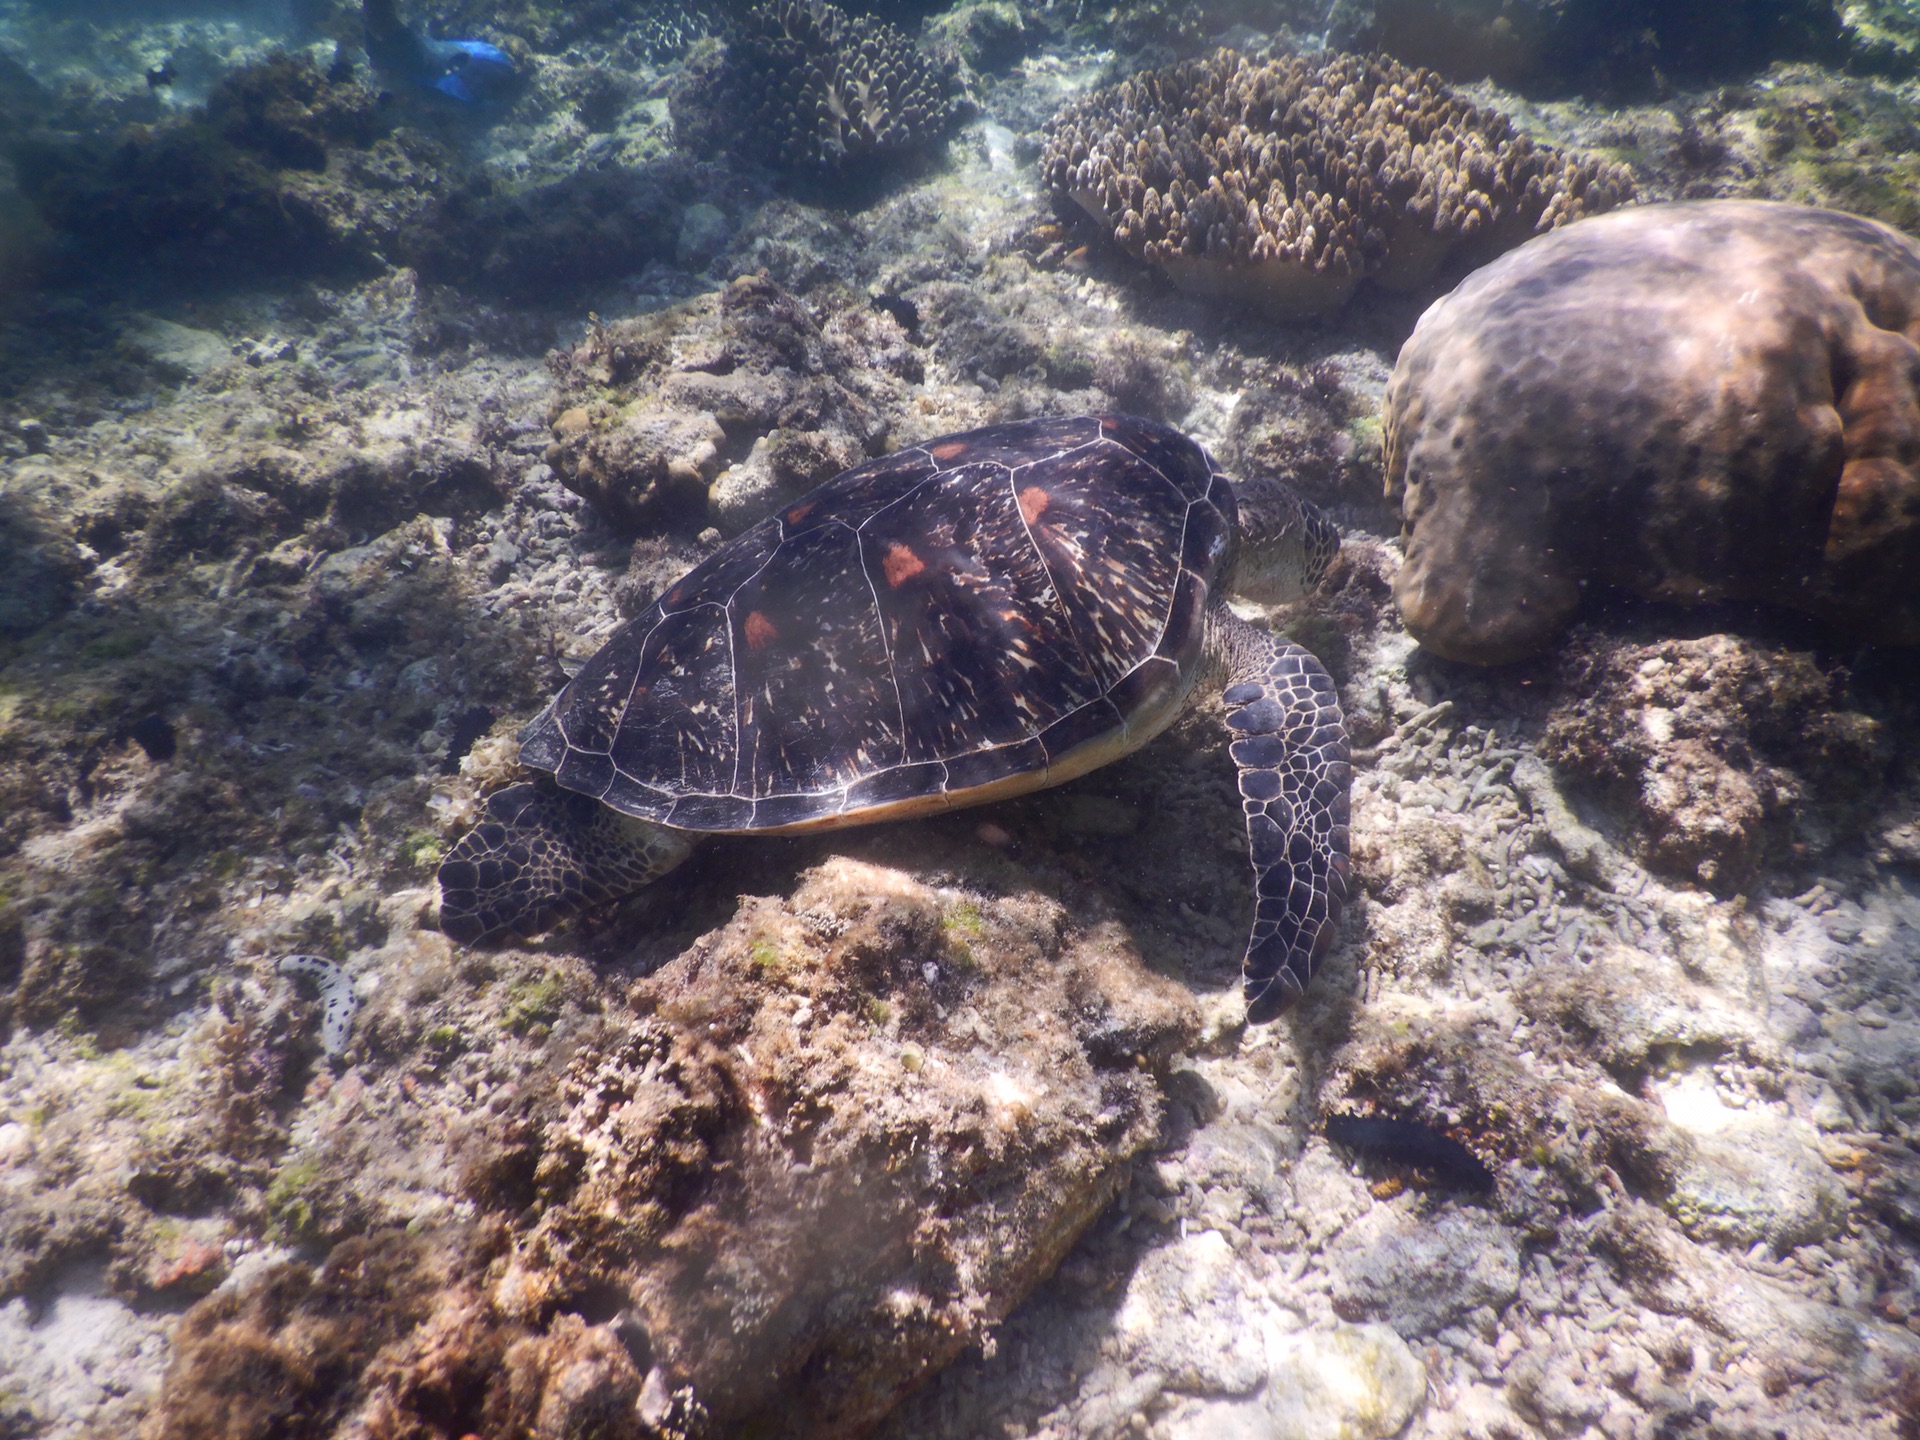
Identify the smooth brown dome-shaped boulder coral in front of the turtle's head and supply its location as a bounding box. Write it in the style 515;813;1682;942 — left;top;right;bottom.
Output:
1386;200;1920;664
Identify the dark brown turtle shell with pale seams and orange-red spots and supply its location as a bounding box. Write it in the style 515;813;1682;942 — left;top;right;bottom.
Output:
520;417;1235;831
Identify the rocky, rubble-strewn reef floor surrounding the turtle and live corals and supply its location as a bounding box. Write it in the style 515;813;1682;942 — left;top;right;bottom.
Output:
0;0;1920;1440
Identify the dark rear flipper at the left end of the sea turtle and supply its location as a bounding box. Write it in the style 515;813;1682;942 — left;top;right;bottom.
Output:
440;785;695;945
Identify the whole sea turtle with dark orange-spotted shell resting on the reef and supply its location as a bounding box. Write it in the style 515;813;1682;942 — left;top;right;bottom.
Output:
440;415;1350;1020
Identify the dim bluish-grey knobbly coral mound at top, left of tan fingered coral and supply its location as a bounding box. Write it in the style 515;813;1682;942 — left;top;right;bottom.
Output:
674;0;962;180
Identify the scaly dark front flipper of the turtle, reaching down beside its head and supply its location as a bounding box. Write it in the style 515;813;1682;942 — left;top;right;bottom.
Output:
1213;607;1354;1023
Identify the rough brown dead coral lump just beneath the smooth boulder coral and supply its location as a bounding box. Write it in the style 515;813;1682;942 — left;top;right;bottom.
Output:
1542;634;1889;889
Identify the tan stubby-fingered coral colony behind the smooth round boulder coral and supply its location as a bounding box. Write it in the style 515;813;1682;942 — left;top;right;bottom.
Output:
1041;50;1634;317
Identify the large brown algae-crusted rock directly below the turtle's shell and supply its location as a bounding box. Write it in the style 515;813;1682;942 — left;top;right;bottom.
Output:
480;860;1194;1436
